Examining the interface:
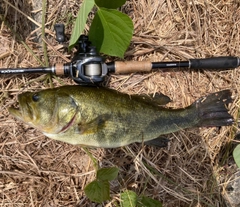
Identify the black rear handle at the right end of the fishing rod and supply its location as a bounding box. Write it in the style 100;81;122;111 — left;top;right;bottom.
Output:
189;56;240;69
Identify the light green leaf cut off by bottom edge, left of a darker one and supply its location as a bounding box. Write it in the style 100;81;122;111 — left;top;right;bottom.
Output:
120;190;137;207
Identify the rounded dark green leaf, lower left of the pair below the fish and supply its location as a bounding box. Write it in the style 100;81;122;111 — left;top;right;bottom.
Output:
84;180;110;203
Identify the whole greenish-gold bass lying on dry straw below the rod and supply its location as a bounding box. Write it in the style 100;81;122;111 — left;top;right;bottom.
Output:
9;85;234;148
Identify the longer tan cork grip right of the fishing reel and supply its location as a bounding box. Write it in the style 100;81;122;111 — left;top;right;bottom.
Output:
115;61;152;74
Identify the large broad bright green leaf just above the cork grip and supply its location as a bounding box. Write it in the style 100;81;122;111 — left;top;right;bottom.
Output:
89;8;133;58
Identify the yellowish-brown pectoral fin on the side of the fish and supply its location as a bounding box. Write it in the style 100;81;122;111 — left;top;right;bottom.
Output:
78;114;110;134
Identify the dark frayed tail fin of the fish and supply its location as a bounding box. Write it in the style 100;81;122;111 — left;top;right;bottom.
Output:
194;90;234;127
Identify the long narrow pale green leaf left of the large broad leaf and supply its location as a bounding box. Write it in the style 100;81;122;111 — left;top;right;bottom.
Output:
69;0;94;49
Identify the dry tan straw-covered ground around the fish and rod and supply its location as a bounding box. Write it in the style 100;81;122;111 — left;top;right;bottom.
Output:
0;0;240;207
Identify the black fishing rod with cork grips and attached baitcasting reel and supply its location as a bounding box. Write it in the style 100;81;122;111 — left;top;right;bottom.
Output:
0;24;240;84
